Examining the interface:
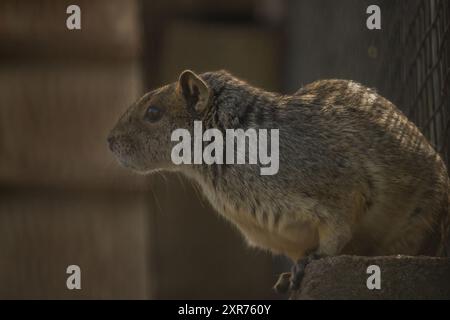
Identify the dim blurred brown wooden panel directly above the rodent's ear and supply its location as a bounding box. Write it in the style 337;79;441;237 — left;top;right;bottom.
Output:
161;21;281;90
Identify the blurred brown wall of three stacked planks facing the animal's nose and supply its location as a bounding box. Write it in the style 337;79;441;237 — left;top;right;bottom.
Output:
0;0;151;298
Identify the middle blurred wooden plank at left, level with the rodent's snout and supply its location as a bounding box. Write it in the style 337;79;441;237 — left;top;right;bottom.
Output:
0;64;143;189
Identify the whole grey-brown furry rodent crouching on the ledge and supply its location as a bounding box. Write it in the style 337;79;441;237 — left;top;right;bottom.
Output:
108;70;449;291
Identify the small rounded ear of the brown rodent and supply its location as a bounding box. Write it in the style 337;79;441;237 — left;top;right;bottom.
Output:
177;70;211;113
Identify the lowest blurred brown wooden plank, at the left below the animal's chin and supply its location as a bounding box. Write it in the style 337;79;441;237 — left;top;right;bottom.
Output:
0;191;151;299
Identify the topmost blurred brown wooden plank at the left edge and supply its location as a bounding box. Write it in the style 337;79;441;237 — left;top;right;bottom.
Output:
0;0;140;60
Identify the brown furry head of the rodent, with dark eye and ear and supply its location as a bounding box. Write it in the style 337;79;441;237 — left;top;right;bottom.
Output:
107;70;211;173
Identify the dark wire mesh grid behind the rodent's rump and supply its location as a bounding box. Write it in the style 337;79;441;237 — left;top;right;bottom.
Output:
379;0;450;168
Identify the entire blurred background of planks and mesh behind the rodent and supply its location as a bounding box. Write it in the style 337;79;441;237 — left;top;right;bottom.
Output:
0;0;450;299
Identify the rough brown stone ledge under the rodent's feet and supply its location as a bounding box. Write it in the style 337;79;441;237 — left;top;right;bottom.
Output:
291;256;450;300
